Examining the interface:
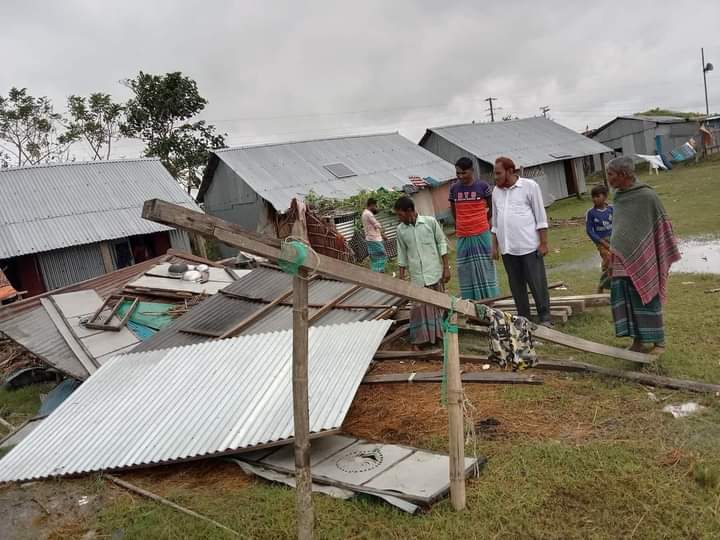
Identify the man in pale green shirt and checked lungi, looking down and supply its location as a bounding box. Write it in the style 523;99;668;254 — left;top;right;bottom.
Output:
395;197;450;346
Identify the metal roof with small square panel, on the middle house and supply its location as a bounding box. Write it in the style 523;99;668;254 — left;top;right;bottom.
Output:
198;133;455;212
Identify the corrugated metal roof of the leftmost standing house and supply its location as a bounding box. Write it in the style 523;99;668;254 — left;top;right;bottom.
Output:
0;159;200;259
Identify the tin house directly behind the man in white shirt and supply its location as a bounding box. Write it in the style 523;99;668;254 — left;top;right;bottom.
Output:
420;117;610;205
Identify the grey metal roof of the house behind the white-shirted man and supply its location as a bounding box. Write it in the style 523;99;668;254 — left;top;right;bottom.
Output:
428;117;612;167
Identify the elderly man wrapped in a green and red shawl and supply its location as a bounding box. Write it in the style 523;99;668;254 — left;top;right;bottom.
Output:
607;157;680;354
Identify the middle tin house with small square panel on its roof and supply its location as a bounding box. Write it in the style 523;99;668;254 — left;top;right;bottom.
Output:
198;133;455;255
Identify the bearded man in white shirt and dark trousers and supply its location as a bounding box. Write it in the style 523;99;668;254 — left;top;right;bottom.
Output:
492;157;550;326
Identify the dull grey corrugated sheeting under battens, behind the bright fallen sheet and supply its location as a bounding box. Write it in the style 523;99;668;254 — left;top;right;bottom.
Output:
134;267;402;352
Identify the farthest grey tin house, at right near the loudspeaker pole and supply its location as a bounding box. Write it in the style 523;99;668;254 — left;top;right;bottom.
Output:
590;114;700;170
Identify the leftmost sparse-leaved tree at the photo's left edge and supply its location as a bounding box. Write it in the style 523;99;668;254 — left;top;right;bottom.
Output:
0;87;74;167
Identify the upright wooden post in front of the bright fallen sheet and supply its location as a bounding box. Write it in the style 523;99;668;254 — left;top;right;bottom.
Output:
292;269;314;540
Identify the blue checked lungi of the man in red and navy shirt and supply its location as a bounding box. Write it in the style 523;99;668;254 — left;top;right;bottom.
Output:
457;231;500;300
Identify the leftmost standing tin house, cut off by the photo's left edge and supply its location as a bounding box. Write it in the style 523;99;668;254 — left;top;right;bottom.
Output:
0;159;200;296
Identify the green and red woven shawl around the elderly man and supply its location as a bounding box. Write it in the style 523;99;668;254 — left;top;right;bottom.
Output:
610;182;680;304
